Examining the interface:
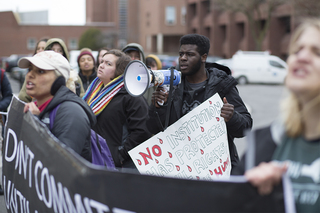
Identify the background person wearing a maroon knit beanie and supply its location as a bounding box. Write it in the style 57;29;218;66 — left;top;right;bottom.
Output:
77;49;97;91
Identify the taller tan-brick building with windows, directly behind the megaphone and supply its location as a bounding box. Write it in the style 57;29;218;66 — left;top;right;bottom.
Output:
86;0;186;54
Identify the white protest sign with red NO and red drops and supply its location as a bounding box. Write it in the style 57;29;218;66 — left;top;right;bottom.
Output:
129;94;231;180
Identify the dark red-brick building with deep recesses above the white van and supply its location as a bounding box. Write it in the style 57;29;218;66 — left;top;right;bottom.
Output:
186;0;295;58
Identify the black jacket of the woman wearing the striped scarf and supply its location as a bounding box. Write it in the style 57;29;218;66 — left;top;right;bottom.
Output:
93;87;151;167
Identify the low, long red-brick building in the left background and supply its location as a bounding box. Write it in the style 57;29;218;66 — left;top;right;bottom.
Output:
0;11;115;57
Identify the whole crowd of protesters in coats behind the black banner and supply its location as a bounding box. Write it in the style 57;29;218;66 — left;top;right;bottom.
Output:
0;20;320;212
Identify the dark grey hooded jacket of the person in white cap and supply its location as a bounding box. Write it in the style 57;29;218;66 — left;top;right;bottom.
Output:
39;86;96;162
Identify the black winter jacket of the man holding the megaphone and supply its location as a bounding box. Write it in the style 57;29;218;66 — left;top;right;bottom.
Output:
147;63;252;170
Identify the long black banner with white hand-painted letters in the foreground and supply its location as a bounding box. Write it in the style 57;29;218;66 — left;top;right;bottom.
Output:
2;98;294;213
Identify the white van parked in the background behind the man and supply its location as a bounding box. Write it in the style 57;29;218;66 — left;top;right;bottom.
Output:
217;51;287;84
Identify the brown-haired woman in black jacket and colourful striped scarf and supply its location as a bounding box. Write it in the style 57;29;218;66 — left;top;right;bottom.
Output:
83;50;150;168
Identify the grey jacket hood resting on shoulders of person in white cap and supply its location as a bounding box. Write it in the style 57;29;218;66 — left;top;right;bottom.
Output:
39;86;97;127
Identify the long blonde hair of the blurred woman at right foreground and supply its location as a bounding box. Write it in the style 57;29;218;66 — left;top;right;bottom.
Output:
281;18;320;137
